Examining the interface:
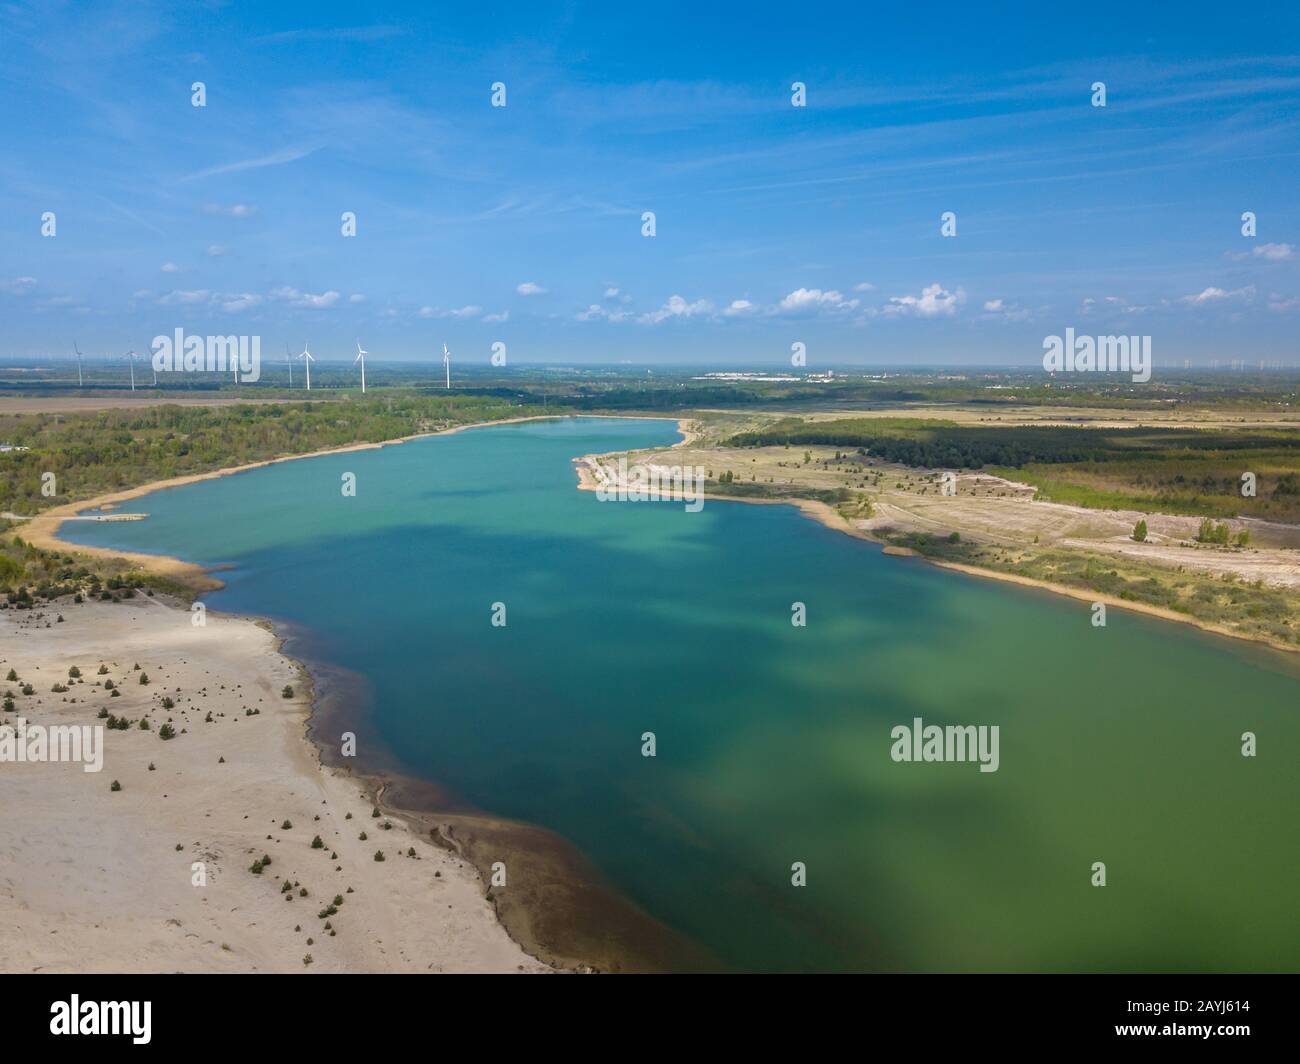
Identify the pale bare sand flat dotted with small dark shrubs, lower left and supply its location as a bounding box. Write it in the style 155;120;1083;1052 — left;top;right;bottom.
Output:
0;596;546;972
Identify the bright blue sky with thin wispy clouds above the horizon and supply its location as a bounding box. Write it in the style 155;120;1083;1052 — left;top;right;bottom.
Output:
0;3;1300;368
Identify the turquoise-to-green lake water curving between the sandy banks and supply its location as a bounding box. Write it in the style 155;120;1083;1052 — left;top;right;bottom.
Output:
65;419;1300;970
